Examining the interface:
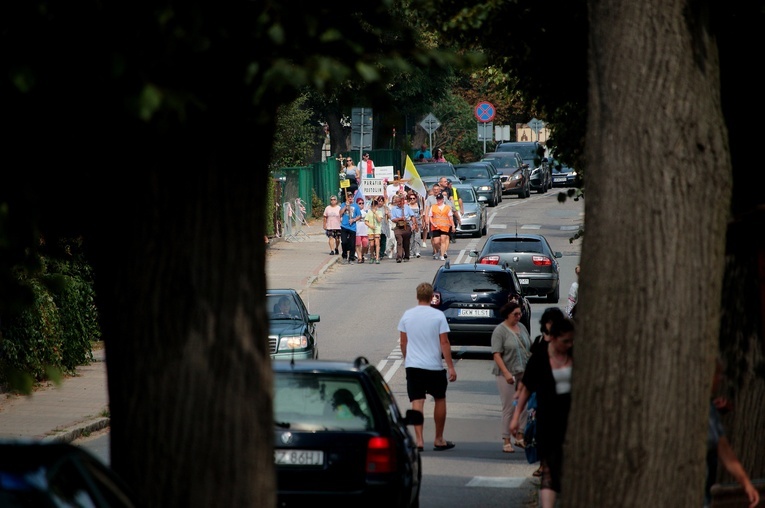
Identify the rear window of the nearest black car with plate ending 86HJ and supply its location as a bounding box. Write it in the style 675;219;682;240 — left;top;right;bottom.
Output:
274;372;374;432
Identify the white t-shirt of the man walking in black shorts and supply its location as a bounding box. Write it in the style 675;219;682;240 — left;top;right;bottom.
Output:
398;305;449;370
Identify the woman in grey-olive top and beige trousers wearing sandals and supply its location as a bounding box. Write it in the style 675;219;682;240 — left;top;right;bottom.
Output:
491;300;531;453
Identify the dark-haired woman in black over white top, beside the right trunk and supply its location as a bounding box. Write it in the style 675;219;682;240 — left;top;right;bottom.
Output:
510;318;574;508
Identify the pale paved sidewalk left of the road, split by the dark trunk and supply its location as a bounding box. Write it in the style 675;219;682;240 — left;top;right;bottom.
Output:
0;220;339;442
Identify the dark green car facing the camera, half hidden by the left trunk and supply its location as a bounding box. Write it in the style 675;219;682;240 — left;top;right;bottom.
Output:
266;289;321;360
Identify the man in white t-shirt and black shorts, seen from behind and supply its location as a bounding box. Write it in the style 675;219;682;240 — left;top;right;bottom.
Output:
398;282;457;451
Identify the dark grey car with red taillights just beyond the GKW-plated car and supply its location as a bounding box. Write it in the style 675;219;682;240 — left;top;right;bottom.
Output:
478;233;563;303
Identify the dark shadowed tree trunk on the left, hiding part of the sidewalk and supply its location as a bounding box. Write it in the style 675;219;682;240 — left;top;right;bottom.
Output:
93;125;276;507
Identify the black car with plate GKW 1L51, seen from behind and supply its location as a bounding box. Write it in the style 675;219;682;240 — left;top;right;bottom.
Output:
430;258;531;346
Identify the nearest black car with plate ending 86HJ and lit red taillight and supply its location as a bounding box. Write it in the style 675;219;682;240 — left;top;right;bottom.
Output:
272;357;423;508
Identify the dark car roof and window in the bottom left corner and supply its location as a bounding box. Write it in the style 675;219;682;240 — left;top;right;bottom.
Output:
0;441;138;508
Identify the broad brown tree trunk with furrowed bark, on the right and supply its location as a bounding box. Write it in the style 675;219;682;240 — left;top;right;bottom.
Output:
563;0;731;507
